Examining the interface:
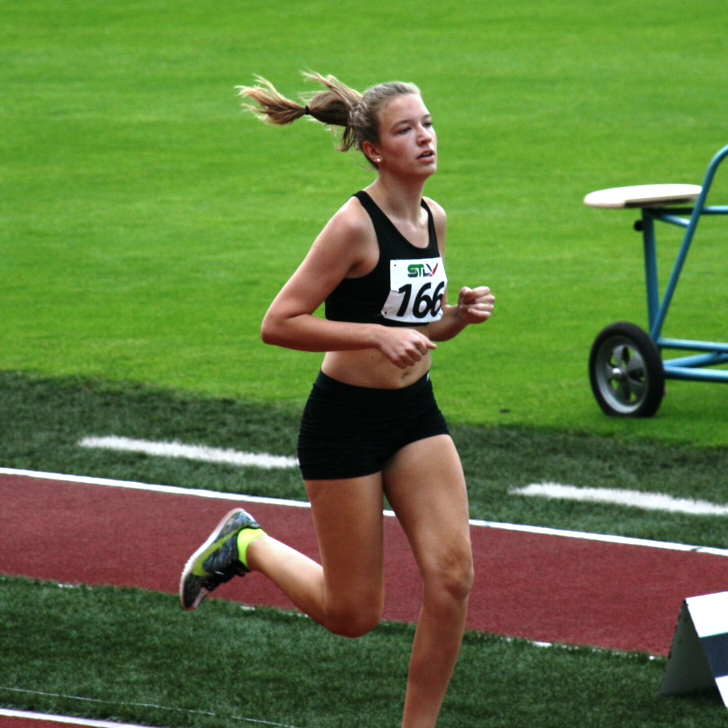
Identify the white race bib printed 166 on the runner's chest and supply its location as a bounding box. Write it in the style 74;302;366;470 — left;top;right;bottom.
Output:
382;258;447;326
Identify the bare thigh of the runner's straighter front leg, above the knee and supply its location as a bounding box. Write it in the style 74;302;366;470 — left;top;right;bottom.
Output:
384;435;472;578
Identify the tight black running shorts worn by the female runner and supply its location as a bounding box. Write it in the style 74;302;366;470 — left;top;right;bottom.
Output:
298;372;449;480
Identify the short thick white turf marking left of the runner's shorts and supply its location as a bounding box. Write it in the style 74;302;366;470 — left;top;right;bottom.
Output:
78;435;298;470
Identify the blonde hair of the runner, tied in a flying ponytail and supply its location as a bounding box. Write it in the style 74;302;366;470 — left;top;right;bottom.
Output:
237;73;420;167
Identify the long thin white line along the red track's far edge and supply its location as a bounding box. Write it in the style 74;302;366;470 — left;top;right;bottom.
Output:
0;468;728;557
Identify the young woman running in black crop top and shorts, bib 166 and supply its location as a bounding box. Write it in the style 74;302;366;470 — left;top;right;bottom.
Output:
180;69;495;728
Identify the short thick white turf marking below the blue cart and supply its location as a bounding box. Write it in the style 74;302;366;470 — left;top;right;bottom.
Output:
509;483;728;516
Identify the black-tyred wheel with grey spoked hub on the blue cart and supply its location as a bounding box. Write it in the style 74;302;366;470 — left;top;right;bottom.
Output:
589;323;665;417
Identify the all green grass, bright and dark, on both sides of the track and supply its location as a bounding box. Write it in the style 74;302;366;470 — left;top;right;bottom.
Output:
0;0;728;728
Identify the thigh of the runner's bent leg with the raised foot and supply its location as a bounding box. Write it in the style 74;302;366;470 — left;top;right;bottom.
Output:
306;473;384;604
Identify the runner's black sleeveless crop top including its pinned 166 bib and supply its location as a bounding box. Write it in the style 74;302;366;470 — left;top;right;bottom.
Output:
325;191;447;326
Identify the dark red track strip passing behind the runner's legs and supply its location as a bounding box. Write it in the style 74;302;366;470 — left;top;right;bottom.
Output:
0;475;728;655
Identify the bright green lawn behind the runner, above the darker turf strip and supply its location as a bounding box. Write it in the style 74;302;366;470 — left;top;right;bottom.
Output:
0;0;728;445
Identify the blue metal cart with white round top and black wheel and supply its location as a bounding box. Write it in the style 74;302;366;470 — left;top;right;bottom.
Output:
584;146;728;417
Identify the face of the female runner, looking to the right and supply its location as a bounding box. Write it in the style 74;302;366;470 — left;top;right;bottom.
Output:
365;94;437;176
